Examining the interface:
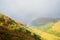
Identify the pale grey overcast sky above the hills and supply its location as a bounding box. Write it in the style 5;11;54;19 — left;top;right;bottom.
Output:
0;0;60;24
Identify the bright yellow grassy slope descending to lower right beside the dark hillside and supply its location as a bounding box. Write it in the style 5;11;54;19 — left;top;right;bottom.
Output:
31;28;60;40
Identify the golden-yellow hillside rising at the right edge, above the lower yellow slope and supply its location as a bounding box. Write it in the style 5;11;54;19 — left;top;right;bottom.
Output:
47;21;60;37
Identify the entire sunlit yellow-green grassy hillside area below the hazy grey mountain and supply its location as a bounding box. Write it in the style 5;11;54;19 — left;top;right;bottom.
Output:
27;21;60;40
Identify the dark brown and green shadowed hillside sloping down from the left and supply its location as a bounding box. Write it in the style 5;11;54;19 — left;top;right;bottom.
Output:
0;14;41;40
